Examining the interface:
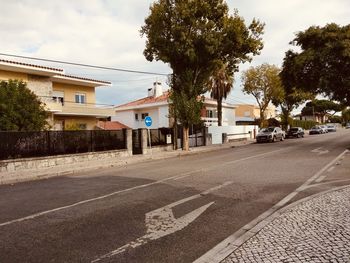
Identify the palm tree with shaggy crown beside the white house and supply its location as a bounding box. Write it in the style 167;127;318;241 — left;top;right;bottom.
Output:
209;64;233;126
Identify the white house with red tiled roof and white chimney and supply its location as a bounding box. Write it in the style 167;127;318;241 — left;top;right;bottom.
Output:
111;82;236;129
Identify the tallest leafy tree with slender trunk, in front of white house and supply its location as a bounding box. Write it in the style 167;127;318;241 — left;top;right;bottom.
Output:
141;0;264;150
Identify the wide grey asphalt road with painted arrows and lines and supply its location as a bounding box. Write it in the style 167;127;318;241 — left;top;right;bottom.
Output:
0;130;350;263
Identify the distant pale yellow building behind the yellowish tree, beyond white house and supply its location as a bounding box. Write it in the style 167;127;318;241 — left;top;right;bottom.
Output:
235;104;276;121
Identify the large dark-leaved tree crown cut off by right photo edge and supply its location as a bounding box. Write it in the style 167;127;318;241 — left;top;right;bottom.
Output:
291;23;350;106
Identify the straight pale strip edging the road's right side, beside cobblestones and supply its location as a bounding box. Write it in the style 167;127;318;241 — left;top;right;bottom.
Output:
193;150;348;263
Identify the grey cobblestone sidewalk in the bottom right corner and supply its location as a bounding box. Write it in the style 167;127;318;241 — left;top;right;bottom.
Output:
222;187;350;263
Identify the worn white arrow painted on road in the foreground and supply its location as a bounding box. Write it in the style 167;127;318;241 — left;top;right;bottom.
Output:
91;182;232;263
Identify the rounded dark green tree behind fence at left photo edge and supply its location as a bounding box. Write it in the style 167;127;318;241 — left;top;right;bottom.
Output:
0;80;48;131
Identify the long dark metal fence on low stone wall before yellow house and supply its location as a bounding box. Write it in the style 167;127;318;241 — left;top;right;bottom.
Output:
0;130;126;160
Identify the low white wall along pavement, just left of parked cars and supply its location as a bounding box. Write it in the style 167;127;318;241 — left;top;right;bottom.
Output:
208;125;258;144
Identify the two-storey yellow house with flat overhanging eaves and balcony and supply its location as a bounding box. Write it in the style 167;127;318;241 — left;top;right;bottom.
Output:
0;59;113;130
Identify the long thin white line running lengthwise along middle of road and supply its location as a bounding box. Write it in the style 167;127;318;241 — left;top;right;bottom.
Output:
0;150;284;227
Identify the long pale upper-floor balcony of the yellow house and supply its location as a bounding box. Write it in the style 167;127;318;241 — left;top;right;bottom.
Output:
42;99;114;118
